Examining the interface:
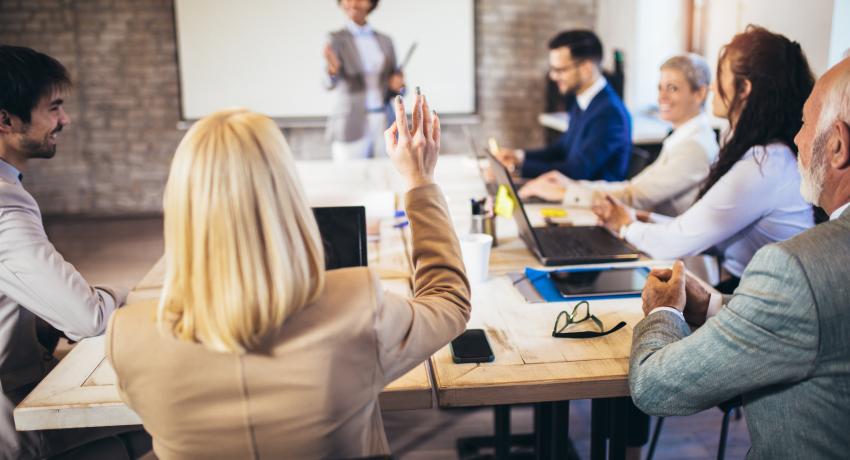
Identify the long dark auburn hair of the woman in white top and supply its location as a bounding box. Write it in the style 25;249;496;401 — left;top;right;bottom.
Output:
699;25;815;198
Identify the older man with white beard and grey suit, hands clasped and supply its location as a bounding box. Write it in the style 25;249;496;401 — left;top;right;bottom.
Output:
629;59;850;459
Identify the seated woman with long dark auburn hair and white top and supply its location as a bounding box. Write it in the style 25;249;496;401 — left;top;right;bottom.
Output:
595;25;815;293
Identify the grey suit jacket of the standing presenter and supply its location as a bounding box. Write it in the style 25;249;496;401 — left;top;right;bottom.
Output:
326;29;396;142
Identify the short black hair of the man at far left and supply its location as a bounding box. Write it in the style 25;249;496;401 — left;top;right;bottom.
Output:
0;45;71;123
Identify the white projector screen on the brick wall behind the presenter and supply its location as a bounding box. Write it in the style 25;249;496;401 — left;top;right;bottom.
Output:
174;0;475;120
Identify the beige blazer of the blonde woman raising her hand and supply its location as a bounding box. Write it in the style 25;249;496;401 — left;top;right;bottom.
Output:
106;185;470;459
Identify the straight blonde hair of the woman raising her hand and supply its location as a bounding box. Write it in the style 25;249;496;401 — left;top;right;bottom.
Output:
157;109;325;353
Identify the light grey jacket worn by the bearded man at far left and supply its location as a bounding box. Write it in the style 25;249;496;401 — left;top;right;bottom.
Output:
0;169;124;459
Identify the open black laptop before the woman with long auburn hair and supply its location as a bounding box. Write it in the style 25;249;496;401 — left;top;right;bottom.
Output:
489;155;640;266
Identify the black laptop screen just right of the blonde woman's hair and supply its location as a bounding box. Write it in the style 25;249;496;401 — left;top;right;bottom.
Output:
313;206;369;270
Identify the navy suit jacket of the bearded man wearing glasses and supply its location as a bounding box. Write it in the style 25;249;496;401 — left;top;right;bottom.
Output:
521;85;632;181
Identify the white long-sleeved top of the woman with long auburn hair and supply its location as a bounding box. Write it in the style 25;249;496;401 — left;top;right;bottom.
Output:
624;144;814;277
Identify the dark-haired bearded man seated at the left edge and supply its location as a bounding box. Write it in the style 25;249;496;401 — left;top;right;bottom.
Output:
0;45;150;459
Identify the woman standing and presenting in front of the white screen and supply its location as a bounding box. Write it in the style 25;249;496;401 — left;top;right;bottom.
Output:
324;0;404;161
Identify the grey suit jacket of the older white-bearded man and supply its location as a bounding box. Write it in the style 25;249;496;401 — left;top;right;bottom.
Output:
629;212;850;459
